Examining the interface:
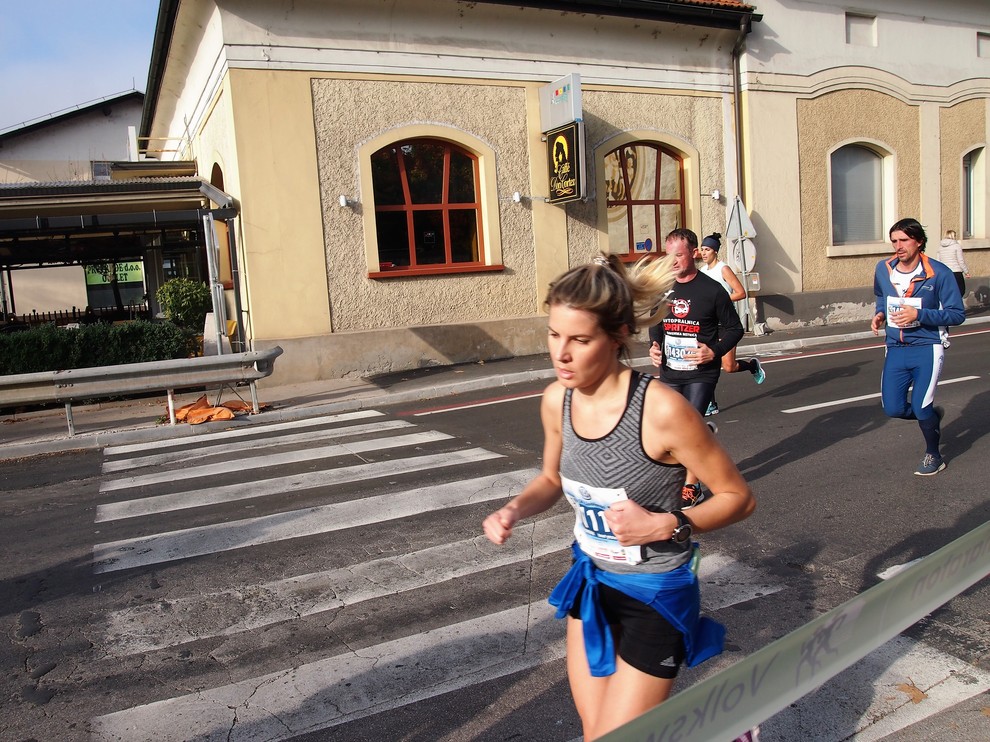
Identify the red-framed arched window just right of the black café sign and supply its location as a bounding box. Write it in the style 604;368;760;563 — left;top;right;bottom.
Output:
602;141;687;259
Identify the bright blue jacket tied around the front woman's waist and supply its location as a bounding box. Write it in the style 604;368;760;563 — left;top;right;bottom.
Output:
550;544;725;678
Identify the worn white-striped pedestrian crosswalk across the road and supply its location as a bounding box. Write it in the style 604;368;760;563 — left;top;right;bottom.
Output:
91;410;988;741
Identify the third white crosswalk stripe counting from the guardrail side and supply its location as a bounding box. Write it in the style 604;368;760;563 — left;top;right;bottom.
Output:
100;430;453;492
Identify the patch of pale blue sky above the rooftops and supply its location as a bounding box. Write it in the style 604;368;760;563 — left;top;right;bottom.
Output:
0;0;159;131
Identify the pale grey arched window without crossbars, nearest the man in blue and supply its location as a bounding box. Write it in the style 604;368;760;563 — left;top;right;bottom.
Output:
831;144;886;245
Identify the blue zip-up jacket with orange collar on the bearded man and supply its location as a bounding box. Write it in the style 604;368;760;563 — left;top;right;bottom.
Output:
873;253;966;345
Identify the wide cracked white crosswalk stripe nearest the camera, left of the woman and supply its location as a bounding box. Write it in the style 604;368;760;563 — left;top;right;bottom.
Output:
92;600;564;742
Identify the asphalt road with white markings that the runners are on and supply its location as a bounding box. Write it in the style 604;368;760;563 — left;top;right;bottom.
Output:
0;331;990;742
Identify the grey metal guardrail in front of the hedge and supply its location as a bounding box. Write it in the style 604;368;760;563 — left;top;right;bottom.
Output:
0;346;282;435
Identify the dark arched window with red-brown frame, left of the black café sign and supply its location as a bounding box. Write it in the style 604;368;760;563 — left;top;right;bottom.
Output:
371;138;485;273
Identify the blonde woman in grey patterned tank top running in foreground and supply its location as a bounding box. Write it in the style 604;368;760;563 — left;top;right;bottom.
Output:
484;256;756;742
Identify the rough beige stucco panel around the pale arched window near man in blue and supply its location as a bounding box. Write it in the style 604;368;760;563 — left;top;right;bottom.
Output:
798;90;922;291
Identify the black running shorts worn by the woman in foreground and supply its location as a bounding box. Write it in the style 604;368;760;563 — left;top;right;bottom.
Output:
569;583;684;679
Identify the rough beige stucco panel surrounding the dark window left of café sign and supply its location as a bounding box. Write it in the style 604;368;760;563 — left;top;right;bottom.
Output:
312;78;537;332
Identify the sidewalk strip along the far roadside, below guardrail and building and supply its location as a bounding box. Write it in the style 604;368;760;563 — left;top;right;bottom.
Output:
0;308;990;461
